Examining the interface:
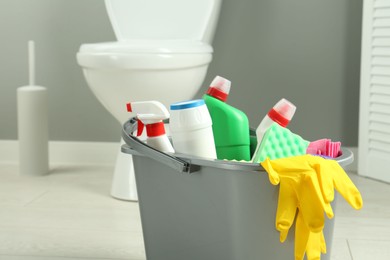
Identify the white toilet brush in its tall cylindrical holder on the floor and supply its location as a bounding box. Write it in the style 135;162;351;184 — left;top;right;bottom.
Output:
17;41;49;176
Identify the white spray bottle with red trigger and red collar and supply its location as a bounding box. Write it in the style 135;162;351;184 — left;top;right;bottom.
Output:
127;101;175;153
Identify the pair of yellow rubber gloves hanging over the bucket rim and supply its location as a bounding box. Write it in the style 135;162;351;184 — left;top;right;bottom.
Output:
261;155;363;260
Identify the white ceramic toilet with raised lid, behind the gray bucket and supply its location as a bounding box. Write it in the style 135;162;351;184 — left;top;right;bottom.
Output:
77;0;222;201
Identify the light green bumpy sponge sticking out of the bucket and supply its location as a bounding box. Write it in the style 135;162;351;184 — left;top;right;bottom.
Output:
253;123;310;163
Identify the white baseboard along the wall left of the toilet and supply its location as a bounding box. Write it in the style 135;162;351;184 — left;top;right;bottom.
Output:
0;140;120;165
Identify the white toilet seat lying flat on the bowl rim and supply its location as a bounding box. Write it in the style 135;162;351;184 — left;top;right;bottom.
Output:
79;40;213;54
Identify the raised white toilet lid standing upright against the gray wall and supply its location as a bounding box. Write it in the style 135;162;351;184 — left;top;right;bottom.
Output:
105;0;222;43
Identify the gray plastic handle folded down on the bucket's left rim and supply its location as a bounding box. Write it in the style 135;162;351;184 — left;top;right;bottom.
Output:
121;117;200;173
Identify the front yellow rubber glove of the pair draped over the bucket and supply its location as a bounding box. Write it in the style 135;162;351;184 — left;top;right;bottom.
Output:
261;156;333;237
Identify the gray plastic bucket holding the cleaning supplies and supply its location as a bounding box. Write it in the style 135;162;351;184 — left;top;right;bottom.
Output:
122;118;353;260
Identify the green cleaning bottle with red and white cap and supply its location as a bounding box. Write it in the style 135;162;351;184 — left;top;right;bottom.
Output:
203;76;251;161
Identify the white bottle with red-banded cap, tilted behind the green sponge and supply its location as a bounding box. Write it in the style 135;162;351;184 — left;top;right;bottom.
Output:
252;98;296;163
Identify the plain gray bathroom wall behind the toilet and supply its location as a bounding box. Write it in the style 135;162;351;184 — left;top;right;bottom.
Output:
0;0;362;146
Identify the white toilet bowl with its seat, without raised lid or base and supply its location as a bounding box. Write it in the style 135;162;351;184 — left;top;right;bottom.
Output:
77;40;213;123
